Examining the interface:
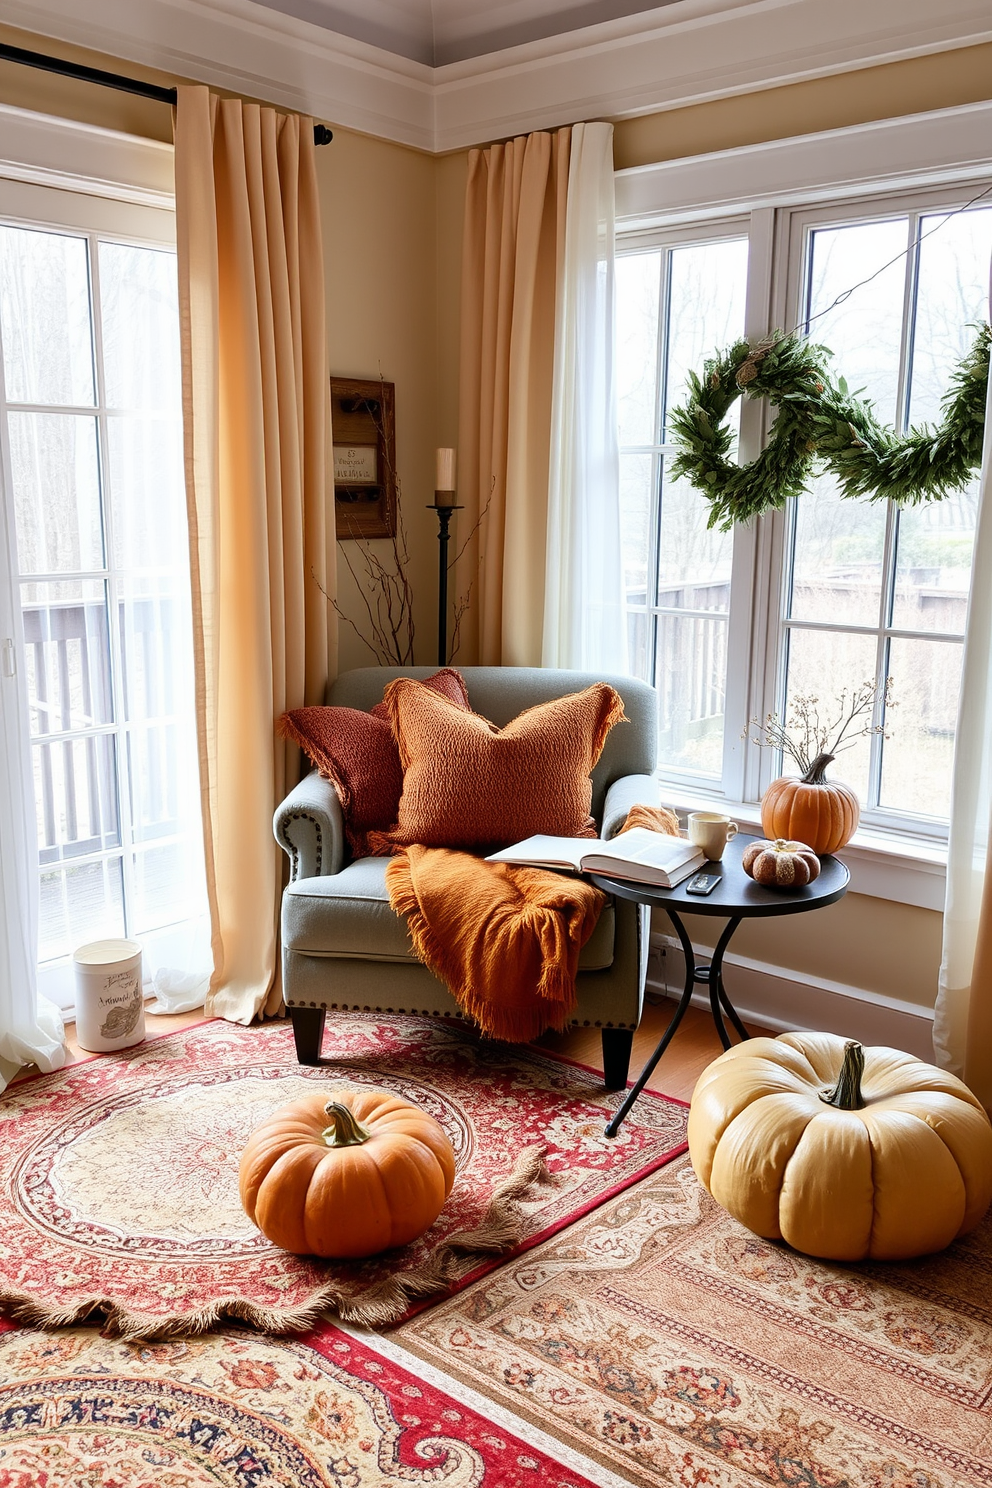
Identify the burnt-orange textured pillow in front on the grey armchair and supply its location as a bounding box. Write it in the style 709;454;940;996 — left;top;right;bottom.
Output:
373;677;623;848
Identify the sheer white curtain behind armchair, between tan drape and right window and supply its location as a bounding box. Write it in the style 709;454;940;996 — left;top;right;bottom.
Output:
541;124;626;673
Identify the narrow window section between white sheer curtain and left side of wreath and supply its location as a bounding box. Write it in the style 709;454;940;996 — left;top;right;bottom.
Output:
617;234;748;781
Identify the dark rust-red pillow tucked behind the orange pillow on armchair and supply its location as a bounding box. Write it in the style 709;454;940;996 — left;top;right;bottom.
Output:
280;667;468;857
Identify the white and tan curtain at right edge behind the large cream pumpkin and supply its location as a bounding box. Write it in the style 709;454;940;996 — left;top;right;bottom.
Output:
934;351;992;1109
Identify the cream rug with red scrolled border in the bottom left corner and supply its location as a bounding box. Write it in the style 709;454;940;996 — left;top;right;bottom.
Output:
0;1324;595;1488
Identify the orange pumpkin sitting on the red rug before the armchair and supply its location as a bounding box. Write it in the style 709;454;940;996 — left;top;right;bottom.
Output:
238;1089;455;1259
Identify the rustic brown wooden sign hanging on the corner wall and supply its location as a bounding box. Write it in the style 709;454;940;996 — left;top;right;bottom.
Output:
330;376;396;537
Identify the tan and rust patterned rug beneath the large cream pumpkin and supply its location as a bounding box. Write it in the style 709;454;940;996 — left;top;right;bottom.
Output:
392;1159;992;1488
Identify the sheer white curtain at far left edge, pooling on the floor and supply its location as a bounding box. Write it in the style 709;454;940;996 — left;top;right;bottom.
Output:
0;499;65;1089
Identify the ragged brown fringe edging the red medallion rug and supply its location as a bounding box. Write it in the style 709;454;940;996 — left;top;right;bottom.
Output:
0;1146;555;1344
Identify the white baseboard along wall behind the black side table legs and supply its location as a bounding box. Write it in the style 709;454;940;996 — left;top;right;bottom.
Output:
647;931;934;1062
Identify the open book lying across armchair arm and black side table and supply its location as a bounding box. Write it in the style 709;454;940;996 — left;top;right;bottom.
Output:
486;827;706;888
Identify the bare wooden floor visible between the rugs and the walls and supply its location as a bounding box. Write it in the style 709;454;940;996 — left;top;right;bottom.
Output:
42;998;767;1101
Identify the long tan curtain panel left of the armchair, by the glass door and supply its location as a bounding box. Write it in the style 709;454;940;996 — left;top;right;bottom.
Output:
175;88;330;1022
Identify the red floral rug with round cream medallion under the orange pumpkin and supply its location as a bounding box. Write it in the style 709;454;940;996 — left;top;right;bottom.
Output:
0;1013;687;1339
